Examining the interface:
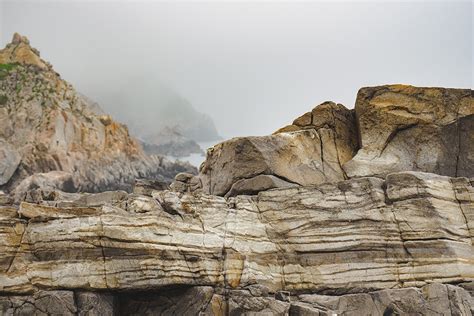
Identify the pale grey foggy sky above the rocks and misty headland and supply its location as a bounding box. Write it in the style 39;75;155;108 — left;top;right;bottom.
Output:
0;0;474;137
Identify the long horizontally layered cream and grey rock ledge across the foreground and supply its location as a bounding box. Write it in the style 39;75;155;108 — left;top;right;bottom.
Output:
0;172;474;315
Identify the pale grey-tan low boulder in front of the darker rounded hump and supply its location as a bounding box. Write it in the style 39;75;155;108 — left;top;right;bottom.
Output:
200;130;338;196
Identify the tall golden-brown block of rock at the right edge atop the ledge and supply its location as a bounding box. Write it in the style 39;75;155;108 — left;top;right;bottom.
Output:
344;85;474;177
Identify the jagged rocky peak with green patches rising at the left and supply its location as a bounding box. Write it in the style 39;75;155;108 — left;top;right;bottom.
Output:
0;34;194;196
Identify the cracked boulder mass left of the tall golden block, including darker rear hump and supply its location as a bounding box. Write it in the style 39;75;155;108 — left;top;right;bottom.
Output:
191;102;358;196
